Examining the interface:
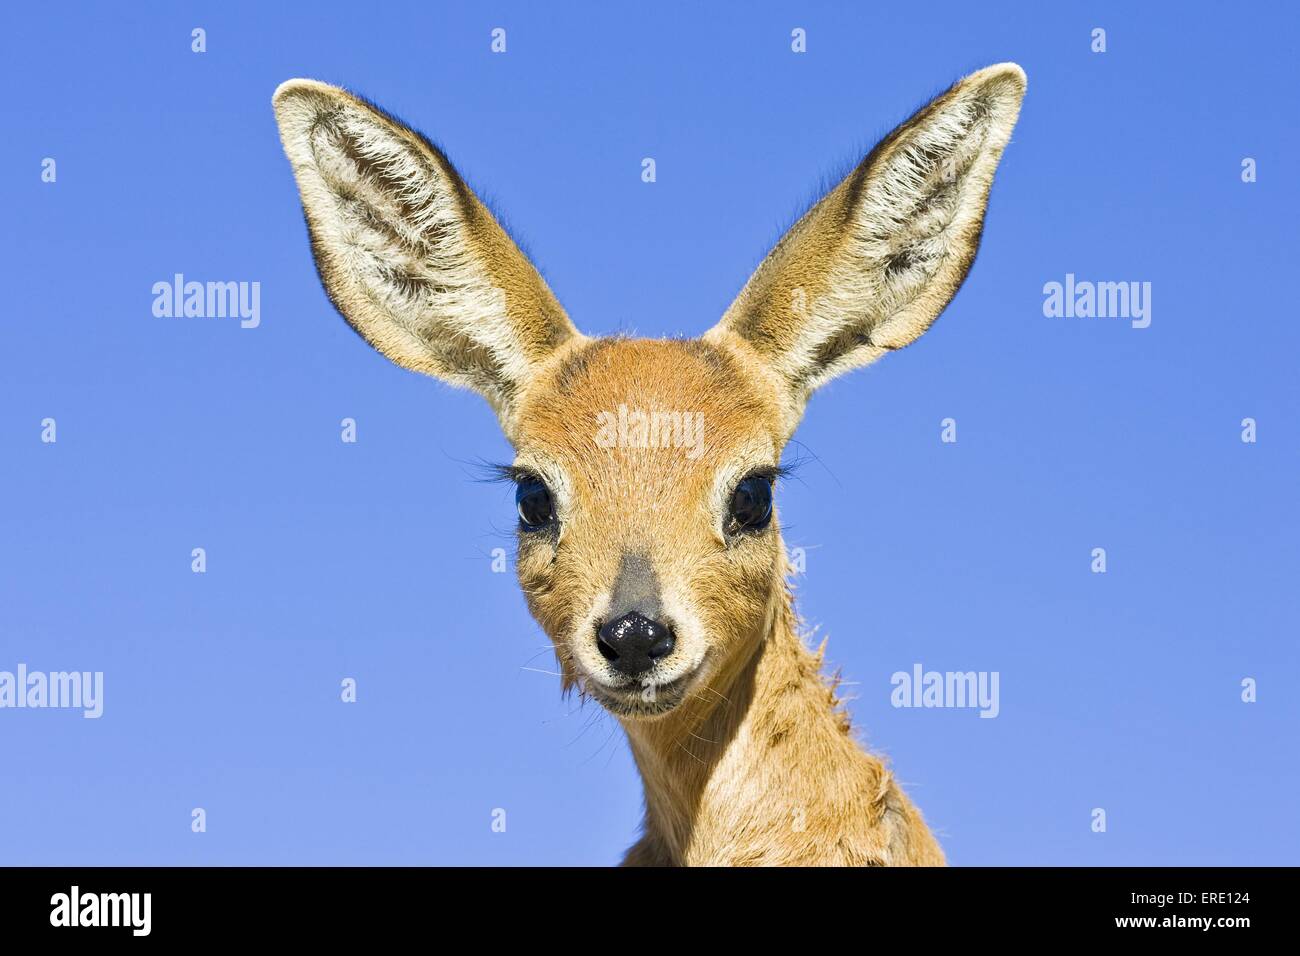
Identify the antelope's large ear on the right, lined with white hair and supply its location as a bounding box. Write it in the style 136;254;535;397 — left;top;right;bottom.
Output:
706;64;1024;431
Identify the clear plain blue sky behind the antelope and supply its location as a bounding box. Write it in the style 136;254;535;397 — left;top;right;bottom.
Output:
0;3;1300;865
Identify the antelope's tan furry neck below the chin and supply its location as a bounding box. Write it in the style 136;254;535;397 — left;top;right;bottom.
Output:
624;574;944;865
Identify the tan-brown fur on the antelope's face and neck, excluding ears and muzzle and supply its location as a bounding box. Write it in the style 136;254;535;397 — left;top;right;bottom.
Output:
519;341;943;865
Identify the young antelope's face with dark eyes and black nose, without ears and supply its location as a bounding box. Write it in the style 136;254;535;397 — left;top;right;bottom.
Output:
512;339;784;718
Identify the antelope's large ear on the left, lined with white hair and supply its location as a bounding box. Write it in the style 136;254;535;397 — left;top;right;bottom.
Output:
274;79;581;437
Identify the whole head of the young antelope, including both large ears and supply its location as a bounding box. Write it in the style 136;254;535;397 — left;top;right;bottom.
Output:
274;64;1024;726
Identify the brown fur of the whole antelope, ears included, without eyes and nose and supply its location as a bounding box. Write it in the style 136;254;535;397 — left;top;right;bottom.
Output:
276;64;1024;865
